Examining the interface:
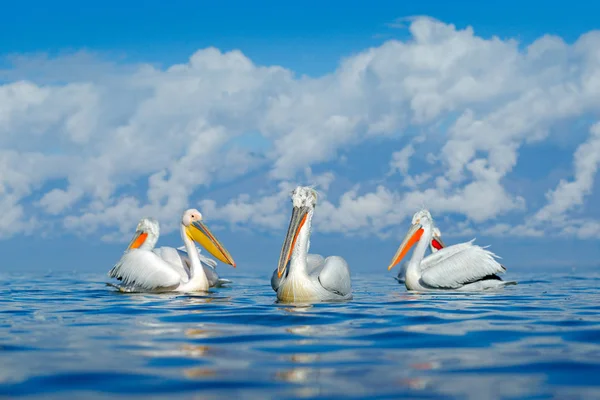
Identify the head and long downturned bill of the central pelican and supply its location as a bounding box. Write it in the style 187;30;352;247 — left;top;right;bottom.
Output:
277;186;317;278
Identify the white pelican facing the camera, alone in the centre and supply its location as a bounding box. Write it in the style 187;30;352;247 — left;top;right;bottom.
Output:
271;186;352;302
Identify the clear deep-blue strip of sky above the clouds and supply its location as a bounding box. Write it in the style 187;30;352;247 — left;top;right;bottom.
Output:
0;0;600;74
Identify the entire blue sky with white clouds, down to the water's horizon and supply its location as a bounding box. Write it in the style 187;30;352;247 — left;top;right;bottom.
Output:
0;1;600;274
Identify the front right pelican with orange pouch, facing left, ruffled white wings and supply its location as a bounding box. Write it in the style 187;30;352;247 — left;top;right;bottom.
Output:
388;210;516;291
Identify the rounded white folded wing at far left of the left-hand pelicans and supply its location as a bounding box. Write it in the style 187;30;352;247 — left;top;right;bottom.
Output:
108;249;182;290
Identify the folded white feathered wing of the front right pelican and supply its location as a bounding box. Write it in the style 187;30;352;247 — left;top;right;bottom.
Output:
421;241;506;289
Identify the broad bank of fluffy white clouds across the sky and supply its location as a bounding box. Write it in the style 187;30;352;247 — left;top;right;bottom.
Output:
0;18;600;240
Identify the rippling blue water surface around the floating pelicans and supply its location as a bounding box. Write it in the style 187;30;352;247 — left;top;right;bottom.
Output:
0;273;600;399
